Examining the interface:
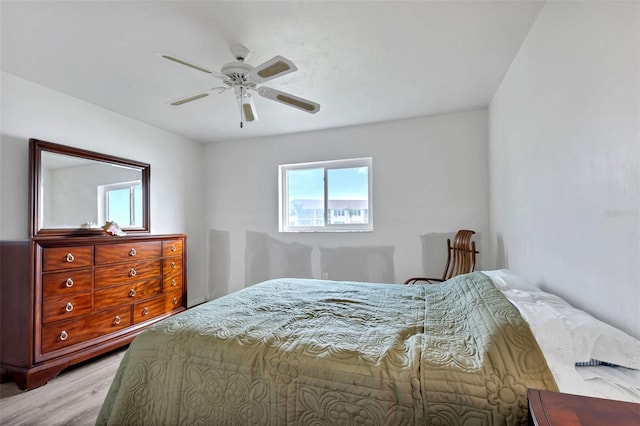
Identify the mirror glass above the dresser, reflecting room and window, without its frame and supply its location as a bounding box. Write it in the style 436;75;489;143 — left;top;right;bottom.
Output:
40;151;142;228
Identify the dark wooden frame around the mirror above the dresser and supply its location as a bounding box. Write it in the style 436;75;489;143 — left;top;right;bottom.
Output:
29;139;151;237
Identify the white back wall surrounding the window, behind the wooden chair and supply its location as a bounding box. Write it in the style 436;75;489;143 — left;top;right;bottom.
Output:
205;109;489;297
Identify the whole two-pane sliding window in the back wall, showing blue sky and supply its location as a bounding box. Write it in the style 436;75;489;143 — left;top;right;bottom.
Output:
278;157;373;232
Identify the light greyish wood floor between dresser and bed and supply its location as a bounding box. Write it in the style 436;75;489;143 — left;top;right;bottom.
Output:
0;348;126;426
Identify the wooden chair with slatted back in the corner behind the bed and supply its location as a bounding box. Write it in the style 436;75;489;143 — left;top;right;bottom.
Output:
404;229;479;284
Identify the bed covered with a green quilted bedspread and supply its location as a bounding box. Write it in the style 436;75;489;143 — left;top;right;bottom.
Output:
97;271;640;425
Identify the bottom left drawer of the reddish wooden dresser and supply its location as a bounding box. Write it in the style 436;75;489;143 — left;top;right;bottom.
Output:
41;306;131;353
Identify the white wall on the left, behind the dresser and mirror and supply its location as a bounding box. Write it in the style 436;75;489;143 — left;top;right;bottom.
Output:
0;73;207;305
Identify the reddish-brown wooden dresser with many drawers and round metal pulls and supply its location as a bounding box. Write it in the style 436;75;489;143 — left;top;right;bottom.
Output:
0;234;187;390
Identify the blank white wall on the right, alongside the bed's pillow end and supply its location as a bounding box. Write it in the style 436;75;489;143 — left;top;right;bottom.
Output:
489;2;640;337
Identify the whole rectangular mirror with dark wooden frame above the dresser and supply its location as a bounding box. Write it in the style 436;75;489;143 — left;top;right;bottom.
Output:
29;139;150;236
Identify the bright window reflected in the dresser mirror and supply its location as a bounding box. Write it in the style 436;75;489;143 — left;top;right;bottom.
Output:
98;181;142;228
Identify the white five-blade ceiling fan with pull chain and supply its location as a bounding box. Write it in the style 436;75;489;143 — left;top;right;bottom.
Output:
160;46;320;127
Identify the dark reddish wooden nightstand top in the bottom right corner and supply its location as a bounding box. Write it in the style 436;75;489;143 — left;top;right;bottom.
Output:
528;389;640;426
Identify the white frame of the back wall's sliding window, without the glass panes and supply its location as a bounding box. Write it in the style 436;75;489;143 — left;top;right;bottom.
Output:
278;157;373;232
